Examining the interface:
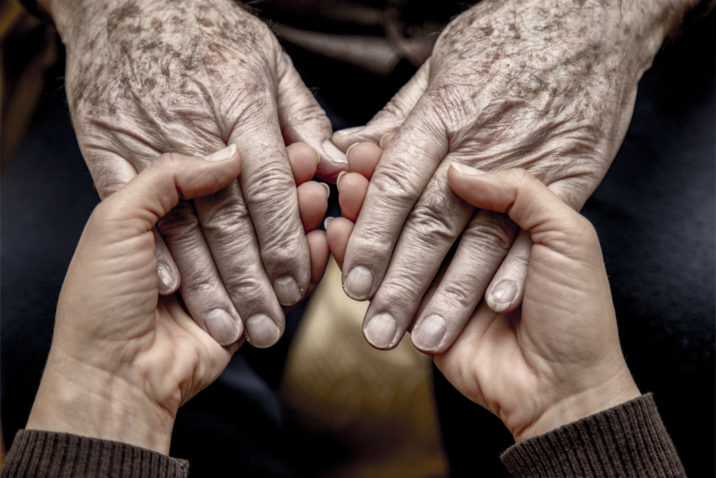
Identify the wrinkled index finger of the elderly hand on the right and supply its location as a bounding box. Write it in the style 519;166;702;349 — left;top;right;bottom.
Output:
343;96;448;300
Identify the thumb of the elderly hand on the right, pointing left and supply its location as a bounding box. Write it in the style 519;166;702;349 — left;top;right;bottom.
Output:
332;60;430;151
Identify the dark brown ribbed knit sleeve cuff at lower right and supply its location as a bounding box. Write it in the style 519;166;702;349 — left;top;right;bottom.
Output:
500;394;686;477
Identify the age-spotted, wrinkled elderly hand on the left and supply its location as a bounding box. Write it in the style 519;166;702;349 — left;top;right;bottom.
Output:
44;0;345;347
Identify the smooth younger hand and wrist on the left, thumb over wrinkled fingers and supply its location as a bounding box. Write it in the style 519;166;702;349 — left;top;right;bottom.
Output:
27;146;327;453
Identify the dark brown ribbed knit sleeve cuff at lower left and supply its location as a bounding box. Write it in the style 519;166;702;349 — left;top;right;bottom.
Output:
0;430;189;478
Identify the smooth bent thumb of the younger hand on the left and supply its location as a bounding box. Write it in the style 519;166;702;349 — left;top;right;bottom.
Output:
98;145;241;236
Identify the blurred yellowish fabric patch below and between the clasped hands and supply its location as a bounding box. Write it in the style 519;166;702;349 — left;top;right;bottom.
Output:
279;260;448;478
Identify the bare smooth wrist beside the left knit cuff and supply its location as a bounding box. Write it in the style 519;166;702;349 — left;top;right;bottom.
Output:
26;352;176;454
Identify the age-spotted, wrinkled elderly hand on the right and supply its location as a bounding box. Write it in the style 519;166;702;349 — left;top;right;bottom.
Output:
333;0;694;353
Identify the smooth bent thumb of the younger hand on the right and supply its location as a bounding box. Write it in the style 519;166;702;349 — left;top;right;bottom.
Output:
448;164;586;246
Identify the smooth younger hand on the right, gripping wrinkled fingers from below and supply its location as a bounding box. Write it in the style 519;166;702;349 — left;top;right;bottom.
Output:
327;162;639;442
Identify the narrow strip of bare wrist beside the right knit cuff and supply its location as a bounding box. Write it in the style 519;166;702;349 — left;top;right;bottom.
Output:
510;366;641;442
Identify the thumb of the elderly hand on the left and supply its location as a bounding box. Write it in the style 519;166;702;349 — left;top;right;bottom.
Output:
277;53;347;182
